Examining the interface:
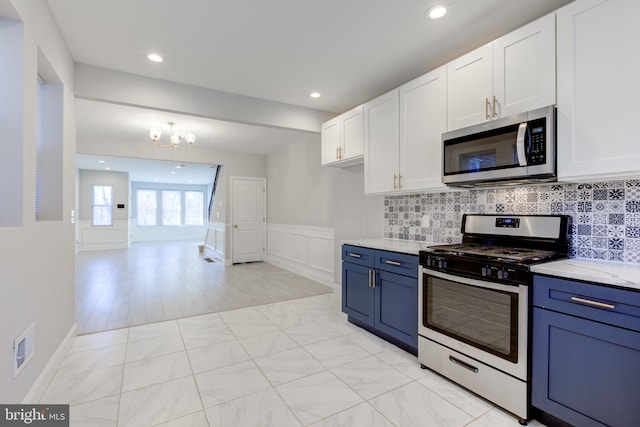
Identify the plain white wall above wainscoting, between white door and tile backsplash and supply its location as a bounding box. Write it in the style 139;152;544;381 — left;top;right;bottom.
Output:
267;134;384;283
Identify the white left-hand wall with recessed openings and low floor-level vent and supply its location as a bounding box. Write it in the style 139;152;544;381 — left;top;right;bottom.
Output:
0;0;75;403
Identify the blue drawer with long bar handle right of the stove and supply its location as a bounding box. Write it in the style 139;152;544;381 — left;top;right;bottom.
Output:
533;276;640;331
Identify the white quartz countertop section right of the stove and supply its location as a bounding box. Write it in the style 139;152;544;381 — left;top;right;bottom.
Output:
531;259;640;291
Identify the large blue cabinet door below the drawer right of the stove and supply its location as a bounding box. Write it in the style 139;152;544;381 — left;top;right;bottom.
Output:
531;308;640;427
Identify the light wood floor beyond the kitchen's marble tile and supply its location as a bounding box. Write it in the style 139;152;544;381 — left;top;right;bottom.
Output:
76;241;331;334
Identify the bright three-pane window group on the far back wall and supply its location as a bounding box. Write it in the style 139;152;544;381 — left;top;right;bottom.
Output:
134;184;205;226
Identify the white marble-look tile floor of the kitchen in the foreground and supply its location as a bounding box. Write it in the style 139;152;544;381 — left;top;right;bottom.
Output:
42;293;541;427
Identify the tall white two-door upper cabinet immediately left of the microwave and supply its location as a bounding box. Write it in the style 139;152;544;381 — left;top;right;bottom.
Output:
364;67;447;194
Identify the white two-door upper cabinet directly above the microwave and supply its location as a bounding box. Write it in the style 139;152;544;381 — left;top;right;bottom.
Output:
447;14;556;130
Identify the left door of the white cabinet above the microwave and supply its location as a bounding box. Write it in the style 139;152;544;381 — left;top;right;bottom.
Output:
447;44;493;130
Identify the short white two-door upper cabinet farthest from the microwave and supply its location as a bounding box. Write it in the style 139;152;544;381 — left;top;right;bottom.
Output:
321;105;364;166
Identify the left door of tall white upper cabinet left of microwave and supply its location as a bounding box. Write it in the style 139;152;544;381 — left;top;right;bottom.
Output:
364;89;400;194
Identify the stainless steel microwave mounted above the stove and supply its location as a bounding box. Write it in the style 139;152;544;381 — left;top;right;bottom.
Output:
442;106;557;187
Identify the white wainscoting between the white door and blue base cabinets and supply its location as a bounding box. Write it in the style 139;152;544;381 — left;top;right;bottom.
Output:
266;224;335;286
